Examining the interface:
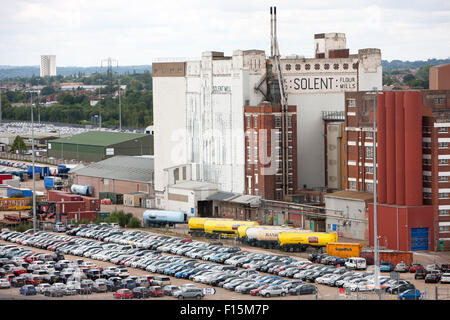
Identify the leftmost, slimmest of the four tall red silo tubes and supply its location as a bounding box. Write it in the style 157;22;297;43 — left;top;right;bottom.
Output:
374;94;387;203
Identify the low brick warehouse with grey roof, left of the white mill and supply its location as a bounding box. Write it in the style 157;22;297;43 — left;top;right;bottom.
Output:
71;156;154;197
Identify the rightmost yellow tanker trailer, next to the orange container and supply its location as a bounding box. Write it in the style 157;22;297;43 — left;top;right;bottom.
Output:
278;232;338;252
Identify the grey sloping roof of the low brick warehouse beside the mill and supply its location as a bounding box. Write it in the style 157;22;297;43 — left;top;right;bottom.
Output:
71;156;154;183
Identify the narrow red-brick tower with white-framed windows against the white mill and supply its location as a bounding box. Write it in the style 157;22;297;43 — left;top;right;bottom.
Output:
244;102;297;200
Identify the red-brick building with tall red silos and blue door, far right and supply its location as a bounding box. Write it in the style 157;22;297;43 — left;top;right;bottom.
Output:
346;90;450;251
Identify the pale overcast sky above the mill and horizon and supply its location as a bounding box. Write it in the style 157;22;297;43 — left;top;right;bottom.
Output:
0;0;450;66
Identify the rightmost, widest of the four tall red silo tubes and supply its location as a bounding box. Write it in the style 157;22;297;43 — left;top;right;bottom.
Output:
404;91;423;206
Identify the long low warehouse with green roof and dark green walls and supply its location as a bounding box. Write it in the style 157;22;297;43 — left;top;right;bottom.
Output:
47;131;153;162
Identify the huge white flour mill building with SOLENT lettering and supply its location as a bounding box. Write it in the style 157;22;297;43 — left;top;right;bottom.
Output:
152;11;382;208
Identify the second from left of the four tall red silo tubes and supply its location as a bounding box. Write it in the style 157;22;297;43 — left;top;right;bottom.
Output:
384;91;396;204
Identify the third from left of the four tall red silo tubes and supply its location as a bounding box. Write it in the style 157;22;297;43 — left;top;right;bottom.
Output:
395;92;405;206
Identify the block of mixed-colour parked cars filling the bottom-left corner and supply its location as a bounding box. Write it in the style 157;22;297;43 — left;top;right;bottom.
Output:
0;232;204;299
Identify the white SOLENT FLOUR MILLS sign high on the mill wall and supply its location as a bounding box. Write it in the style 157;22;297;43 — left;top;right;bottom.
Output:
285;75;357;93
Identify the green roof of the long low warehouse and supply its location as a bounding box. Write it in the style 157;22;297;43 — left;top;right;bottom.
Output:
51;131;146;147
